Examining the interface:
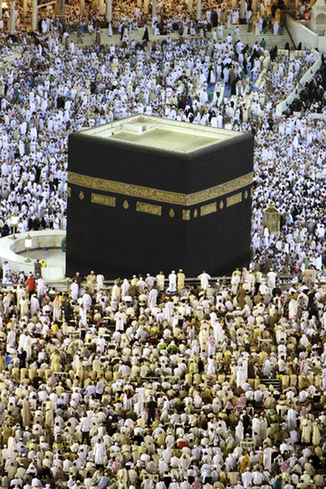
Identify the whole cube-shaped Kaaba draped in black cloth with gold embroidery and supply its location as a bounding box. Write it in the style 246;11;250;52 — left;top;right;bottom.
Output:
66;115;253;279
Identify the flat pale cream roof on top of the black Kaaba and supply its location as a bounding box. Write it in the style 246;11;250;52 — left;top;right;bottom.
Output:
78;115;252;155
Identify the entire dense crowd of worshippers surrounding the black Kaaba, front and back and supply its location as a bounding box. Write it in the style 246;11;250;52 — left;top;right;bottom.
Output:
0;2;326;489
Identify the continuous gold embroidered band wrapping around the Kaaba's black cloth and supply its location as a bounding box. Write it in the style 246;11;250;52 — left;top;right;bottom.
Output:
68;172;253;206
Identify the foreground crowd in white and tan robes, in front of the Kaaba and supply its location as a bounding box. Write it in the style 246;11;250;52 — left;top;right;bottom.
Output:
0;255;326;489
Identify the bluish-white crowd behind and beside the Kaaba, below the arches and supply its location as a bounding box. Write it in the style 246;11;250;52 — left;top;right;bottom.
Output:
0;20;325;271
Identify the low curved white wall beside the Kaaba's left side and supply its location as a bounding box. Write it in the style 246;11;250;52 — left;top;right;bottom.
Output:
0;230;66;281
